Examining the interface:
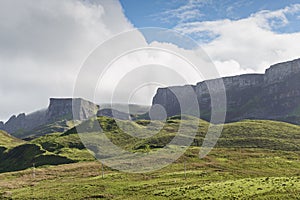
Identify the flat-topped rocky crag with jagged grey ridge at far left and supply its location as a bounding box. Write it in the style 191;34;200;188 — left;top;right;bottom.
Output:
0;98;99;136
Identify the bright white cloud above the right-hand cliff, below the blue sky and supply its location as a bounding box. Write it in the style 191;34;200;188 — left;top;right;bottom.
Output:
175;4;300;75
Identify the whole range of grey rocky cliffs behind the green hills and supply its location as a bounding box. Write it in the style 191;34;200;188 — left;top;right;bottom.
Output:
0;59;300;139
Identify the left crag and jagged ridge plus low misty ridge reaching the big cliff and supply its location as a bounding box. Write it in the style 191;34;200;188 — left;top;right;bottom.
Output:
0;98;150;140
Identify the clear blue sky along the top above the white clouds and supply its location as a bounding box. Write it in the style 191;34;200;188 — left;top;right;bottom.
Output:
120;0;300;33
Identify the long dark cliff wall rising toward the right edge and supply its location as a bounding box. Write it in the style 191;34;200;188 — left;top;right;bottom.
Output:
152;59;300;124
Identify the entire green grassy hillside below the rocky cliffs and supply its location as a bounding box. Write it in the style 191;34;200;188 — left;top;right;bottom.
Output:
0;117;300;199
